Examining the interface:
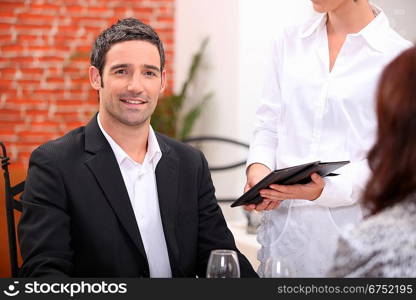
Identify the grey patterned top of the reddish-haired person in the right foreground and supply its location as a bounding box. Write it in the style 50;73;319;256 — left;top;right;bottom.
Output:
329;195;416;277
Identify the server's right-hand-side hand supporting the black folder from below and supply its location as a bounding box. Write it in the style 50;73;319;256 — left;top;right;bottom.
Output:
244;173;325;211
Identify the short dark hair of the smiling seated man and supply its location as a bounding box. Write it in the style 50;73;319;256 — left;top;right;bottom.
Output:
90;18;165;82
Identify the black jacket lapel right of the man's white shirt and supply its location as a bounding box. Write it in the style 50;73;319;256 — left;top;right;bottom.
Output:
156;134;183;277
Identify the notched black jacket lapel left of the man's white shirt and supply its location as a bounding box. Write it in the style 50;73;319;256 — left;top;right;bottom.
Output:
85;117;147;261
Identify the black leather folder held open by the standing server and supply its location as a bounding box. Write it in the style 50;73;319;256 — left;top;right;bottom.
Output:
231;161;349;207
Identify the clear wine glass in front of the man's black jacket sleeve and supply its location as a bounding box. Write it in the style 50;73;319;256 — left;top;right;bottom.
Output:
207;249;240;278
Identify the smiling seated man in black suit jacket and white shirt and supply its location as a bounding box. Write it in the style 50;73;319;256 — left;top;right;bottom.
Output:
19;18;257;277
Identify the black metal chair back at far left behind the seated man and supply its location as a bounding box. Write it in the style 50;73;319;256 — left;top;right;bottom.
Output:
0;142;25;277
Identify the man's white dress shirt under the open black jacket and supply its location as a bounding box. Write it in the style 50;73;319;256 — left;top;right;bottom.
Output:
97;115;172;278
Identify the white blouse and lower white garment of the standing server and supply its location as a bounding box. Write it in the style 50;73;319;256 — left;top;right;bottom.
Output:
247;6;411;276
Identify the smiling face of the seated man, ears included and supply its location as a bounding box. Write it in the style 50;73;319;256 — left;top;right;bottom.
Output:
90;40;166;126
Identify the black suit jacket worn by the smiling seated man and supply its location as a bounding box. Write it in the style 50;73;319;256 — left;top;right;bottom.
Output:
18;117;257;277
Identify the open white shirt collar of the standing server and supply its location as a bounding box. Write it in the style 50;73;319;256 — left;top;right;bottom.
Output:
299;4;390;52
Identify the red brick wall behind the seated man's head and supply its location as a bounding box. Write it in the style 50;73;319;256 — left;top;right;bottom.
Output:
0;0;175;167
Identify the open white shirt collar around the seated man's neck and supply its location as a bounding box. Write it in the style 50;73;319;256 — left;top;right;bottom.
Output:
97;113;162;170
